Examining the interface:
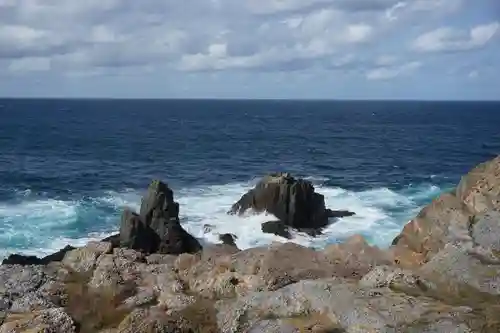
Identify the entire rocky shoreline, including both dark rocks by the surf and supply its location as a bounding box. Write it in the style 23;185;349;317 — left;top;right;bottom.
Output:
0;156;500;333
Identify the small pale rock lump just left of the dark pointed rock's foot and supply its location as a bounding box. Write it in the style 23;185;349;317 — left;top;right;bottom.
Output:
62;242;113;273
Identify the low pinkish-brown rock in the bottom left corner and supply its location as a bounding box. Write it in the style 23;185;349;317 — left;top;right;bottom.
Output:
0;308;77;333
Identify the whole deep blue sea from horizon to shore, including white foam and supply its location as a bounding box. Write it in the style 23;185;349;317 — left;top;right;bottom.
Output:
0;99;500;258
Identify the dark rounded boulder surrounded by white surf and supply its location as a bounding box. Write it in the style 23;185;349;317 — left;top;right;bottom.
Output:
230;173;352;229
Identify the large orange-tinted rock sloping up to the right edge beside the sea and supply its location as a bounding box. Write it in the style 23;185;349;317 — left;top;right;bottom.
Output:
392;156;500;266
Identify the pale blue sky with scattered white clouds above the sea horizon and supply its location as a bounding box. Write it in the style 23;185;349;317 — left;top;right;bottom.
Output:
0;0;500;100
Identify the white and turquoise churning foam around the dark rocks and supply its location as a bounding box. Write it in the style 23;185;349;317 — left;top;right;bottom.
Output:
0;177;442;257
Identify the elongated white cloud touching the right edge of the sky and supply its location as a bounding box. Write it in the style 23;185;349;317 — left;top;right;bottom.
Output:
412;22;500;52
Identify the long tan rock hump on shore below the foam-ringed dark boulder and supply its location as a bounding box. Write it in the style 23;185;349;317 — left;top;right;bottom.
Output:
182;243;362;298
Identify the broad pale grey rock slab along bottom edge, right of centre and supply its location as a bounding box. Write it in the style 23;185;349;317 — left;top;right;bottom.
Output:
217;279;473;333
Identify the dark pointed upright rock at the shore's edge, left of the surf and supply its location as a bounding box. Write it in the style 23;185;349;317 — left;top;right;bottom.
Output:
120;180;201;254
